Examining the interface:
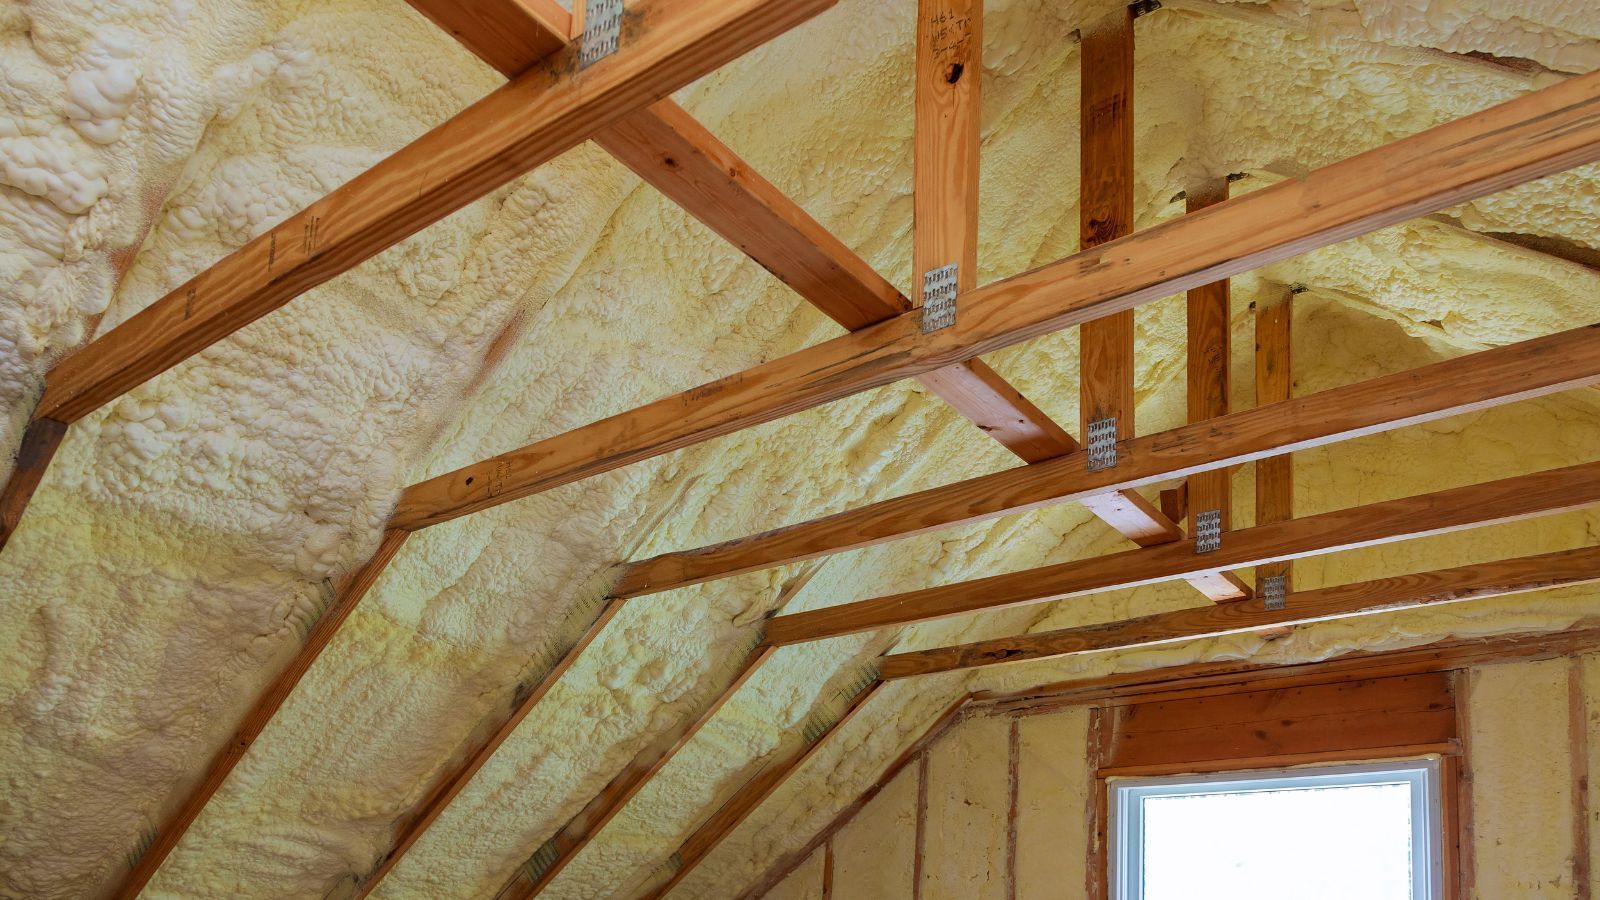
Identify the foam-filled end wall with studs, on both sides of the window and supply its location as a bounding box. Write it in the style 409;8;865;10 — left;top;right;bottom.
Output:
766;655;1600;900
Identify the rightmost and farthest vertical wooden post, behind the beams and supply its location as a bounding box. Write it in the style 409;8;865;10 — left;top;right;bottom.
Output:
1256;288;1294;593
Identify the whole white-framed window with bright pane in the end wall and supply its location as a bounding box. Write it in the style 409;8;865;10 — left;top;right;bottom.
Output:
1107;759;1443;900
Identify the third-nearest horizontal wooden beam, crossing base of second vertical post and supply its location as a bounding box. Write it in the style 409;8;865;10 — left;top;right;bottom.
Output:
614;325;1600;597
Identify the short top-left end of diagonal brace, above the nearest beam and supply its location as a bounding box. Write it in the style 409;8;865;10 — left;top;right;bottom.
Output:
406;0;584;77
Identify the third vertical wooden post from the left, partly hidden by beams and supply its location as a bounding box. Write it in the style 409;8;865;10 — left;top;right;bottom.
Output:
1186;178;1234;535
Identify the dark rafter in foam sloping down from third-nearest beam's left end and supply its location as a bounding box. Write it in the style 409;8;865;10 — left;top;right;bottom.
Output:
354;599;622;898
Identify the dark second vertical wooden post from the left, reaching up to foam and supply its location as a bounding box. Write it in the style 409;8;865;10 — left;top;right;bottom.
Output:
1078;8;1134;440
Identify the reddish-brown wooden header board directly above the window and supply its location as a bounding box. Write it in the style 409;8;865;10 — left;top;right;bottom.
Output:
1101;673;1458;773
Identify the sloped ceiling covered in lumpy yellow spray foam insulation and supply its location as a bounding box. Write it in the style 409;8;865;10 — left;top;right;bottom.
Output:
0;0;1600;897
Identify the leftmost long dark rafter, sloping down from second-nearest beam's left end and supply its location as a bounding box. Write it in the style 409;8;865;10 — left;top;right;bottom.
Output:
112;530;410;900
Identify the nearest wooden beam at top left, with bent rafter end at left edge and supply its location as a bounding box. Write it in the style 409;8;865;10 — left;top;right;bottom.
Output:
0;0;834;546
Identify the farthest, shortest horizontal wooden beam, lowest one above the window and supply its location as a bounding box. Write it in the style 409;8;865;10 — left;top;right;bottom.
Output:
883;538;1600;681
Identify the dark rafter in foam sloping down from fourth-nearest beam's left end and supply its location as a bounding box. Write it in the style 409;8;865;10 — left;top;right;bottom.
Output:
496;644;774;900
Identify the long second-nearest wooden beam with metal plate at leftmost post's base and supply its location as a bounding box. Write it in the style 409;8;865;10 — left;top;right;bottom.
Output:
392;72;1600;528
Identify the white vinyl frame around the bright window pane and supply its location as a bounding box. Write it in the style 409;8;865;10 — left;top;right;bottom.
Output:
1107;756;1445;900
